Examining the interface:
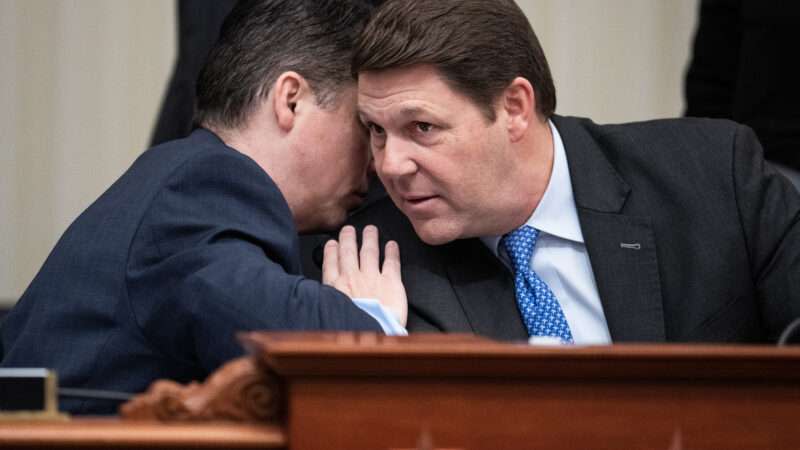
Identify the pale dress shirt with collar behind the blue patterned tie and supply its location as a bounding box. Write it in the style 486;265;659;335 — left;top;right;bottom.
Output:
481;122;611;344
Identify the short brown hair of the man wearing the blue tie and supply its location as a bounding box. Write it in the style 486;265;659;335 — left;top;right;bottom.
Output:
353;0;556;122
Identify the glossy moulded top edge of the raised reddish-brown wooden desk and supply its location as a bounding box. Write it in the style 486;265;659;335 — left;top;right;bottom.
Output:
241;332;800;382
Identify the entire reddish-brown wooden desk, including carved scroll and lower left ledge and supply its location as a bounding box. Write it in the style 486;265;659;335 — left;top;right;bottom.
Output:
0;333;800;450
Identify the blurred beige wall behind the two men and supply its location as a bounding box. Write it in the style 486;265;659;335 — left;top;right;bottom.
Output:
0;0;697;304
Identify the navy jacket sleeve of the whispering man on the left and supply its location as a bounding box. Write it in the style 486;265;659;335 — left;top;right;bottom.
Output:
126;150;380;371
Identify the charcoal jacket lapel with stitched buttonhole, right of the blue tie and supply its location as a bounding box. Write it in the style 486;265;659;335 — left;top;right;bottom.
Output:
553;117;665;342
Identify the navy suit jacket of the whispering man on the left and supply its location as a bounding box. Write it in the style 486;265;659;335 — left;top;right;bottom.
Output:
2;129;380;413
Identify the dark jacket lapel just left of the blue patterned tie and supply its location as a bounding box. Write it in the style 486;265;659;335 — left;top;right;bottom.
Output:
445;239;528;340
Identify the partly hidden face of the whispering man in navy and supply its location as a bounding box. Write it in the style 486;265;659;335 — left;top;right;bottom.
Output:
294;84;370;232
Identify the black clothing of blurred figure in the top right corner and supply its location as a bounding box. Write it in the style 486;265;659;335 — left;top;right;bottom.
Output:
685;0;800;170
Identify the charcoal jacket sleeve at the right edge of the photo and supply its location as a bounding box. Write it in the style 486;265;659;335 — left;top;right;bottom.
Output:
732;125;800;340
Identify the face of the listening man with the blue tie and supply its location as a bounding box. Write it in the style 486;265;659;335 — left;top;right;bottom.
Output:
358;65;514;245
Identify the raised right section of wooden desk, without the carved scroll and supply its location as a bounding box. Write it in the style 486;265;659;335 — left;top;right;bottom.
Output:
244;333;800;450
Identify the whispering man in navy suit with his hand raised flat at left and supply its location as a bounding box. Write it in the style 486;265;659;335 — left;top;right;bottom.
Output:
2;0;406;413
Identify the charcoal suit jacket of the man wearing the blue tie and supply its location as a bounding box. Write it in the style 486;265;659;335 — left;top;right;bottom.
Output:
352;117;800;342
